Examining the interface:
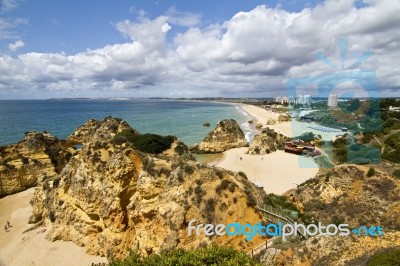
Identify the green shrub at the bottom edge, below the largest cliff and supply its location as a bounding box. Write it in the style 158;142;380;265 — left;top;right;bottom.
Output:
109;245;260;266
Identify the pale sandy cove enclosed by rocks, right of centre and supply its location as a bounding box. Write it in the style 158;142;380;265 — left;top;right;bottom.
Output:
215;148;318;194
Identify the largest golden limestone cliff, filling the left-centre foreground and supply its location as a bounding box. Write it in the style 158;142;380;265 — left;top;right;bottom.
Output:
31;117;264;257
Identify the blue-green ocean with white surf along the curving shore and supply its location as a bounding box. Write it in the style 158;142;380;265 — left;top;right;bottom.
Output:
0;99;254;146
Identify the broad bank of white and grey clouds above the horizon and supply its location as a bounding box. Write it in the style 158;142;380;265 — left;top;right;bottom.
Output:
0;0;400;96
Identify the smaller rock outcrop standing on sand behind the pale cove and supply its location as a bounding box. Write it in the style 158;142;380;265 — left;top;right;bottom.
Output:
247;128;288;155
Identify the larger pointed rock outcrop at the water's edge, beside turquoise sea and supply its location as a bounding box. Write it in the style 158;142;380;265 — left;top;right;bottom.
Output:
192;119;249;153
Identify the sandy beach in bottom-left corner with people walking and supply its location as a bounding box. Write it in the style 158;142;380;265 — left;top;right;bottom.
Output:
0;188;107;266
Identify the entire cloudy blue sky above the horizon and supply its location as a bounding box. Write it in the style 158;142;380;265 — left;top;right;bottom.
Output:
0;0;400;99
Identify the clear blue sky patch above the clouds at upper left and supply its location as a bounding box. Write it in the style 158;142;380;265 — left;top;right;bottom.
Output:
0;0;316;54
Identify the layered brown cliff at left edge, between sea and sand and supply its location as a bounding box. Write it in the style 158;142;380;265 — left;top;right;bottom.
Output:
0;132;74;197
